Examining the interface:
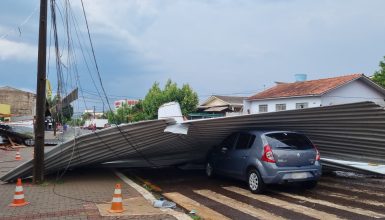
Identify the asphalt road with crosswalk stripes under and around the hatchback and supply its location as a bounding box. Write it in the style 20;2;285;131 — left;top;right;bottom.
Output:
125;168;385;220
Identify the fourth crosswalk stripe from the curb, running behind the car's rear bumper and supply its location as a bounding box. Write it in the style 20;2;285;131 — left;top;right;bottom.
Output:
274;191;385;218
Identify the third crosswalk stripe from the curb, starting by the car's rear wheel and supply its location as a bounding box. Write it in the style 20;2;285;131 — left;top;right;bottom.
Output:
223;186;341;219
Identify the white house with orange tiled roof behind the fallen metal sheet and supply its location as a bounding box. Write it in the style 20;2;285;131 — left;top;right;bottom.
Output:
243;74;385;114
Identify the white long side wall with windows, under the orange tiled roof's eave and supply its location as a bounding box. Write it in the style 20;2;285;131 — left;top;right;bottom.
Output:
243;97;321;114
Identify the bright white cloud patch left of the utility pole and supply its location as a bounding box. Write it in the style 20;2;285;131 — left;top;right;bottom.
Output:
0;39;37;61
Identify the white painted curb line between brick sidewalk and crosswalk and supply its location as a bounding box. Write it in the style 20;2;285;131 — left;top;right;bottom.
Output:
114;170;191;220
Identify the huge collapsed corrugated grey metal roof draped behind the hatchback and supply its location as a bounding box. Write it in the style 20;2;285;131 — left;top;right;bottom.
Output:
1;102;385;181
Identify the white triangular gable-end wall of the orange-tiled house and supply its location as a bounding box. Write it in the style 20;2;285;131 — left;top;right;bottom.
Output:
321;80;385;106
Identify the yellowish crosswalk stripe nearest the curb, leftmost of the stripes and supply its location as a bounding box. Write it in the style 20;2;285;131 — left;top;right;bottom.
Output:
163;192;230;220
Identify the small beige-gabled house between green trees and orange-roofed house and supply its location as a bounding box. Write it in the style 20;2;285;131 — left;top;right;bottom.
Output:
189;95;247;119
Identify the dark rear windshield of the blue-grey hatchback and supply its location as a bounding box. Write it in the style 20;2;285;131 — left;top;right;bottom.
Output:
265;133;313;150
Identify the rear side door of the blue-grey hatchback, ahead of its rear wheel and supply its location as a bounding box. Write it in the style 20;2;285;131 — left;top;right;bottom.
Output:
226;133;255;178
